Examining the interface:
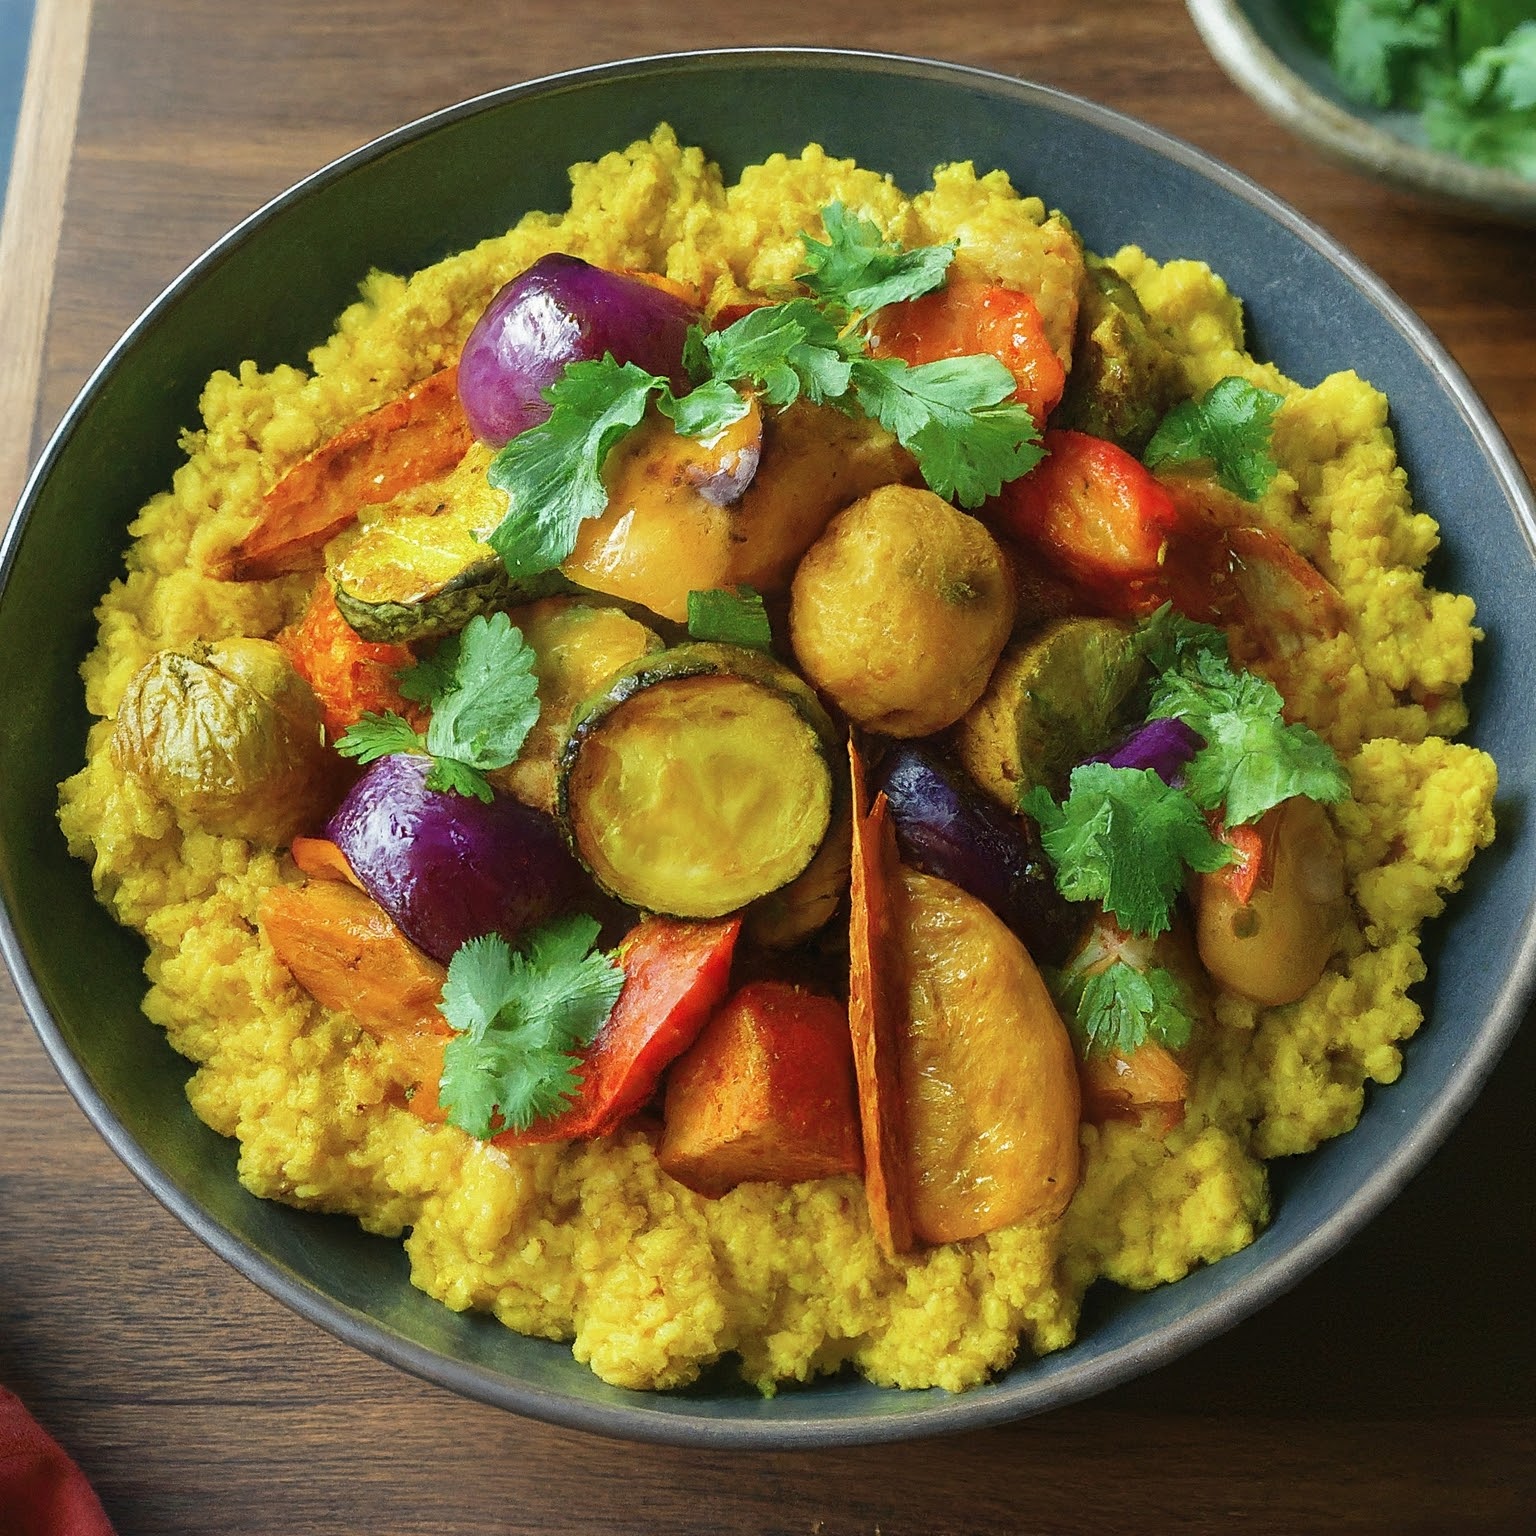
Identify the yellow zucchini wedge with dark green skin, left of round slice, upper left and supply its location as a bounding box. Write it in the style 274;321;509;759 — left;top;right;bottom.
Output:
330;445;567;644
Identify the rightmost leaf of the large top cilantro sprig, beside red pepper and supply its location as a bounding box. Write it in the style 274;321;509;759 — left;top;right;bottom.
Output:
852;356;1044;507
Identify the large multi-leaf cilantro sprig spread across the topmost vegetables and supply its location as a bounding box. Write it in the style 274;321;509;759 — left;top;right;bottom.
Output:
488;203;1043;576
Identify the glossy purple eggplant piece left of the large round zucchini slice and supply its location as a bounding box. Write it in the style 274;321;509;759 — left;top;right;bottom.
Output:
326;753;608;962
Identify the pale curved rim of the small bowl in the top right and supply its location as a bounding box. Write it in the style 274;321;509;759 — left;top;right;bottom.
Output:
1184;0;1536;223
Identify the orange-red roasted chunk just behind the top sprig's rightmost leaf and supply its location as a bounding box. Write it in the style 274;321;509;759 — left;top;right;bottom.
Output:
871;278;1066;427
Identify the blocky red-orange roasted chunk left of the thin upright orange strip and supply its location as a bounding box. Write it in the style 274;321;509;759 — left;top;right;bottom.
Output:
656;982;863;1198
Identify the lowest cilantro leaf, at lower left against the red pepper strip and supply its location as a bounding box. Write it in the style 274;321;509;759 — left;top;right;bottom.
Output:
438;912;624;1140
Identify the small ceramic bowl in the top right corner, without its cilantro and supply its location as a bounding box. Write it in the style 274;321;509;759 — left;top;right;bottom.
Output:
1184;0;1536;224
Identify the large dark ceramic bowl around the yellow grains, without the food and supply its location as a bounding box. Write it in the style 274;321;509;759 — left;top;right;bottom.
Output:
0;51;1536;1447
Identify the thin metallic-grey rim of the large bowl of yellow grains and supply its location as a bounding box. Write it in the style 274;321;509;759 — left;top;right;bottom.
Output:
0;46;1536;1450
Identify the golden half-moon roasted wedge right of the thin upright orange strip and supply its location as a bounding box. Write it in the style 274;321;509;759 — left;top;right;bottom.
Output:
894;869;1080;1243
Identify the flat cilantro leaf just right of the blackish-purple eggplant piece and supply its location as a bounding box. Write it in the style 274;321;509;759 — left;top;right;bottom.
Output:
1021;763;1233;937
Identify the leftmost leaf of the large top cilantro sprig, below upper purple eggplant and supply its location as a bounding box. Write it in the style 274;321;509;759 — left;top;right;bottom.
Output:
487;356;667;576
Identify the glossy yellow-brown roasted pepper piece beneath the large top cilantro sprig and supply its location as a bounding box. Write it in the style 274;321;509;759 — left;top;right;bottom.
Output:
561;402;912;624
